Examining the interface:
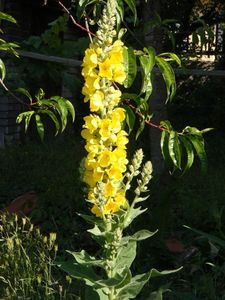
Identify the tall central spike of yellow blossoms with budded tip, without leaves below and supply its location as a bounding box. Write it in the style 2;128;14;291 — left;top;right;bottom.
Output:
81;0;128;217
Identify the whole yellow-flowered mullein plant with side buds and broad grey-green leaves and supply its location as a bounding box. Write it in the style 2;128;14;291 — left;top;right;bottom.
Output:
59;0;181;300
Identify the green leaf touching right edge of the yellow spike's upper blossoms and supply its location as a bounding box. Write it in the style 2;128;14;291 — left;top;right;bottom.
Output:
123;47;137;88
